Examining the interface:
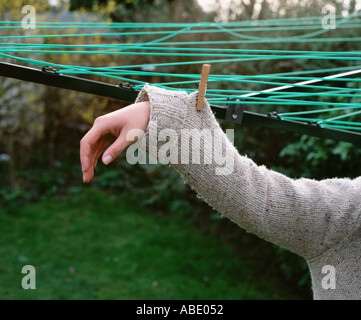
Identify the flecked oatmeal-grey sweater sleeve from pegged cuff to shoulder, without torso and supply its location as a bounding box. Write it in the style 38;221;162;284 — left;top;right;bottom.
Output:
134;86;360;256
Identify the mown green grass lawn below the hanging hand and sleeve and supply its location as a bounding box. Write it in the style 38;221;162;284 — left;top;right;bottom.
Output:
0;188;297;299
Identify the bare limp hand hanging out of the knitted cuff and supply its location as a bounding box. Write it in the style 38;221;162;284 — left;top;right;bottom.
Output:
80;101;150;183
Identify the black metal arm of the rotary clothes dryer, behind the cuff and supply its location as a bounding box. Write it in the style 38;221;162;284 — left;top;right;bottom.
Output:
0;62;361;147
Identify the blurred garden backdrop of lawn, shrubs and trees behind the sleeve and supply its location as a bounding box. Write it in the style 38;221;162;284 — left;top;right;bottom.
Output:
0;0;361;299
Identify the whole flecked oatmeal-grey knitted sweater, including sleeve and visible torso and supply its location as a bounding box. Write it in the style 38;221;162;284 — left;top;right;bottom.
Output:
137;85;361;299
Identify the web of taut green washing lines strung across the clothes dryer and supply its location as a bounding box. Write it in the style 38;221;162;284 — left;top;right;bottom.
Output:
0;13;361;131
